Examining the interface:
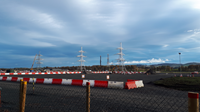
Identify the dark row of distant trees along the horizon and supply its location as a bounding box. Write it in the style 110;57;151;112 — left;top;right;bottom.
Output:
0;65;200;72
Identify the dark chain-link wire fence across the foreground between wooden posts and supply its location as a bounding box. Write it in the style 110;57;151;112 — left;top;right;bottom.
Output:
0;81;199;112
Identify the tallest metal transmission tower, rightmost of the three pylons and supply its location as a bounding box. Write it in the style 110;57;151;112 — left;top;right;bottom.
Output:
117;43;126;73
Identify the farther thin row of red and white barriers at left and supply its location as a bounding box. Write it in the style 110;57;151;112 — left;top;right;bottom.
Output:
0;72;82;75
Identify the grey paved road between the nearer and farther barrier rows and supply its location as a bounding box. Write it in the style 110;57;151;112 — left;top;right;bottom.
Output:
3;73;200;83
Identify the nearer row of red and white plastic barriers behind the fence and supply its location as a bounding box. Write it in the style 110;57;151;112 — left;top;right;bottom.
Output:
0;77;144;89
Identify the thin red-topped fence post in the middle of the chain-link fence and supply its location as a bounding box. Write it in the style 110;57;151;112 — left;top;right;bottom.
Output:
86;82;90;112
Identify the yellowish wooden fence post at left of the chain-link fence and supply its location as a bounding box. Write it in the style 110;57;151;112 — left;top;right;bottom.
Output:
20;81;27;112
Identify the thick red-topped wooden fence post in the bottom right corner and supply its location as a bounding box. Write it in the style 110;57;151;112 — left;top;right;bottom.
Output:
188;92;199;112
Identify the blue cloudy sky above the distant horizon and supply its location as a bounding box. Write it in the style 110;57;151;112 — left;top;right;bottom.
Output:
0;0;200;68
